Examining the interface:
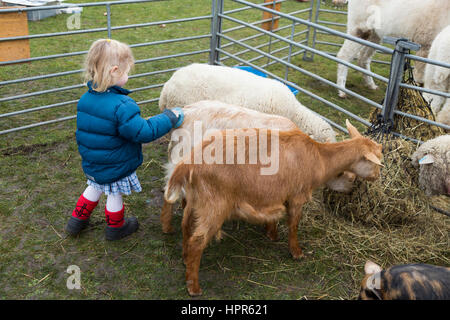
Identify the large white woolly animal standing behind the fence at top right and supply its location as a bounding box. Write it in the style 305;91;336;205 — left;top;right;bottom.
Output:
336;0;450;98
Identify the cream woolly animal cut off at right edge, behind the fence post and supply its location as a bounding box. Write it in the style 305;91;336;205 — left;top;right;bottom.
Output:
423;25;450;125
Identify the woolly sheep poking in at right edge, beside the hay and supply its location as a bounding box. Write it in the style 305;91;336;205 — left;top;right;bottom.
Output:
411;134;450;195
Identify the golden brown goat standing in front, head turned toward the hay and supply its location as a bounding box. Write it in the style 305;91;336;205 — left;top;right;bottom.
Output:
164;121;382;295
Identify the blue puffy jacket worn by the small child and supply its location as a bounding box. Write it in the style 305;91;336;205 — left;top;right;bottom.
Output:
76;82;178;184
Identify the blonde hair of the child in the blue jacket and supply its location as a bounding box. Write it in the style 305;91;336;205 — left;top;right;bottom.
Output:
84;39;134;92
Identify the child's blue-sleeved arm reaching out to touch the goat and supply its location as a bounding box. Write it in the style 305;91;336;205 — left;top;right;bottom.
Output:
116;98;178;143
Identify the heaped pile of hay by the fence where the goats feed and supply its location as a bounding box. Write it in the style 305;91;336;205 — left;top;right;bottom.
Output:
323;139;431;226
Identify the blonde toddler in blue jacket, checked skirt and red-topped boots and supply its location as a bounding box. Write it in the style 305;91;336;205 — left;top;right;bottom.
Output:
66;39;183;240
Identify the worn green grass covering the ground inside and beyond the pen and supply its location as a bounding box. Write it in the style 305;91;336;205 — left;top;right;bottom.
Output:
0;0;449;299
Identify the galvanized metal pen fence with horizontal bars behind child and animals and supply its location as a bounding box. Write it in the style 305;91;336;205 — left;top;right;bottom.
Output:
0;0;450;140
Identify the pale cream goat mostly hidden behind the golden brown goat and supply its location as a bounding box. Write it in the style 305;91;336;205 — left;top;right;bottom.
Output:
161;100;356;234
